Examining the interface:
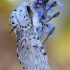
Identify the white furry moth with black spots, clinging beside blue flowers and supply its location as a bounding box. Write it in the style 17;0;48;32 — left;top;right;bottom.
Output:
9;2;50;70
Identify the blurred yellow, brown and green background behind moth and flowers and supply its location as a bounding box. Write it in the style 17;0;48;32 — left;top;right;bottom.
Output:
0;0;70;70
